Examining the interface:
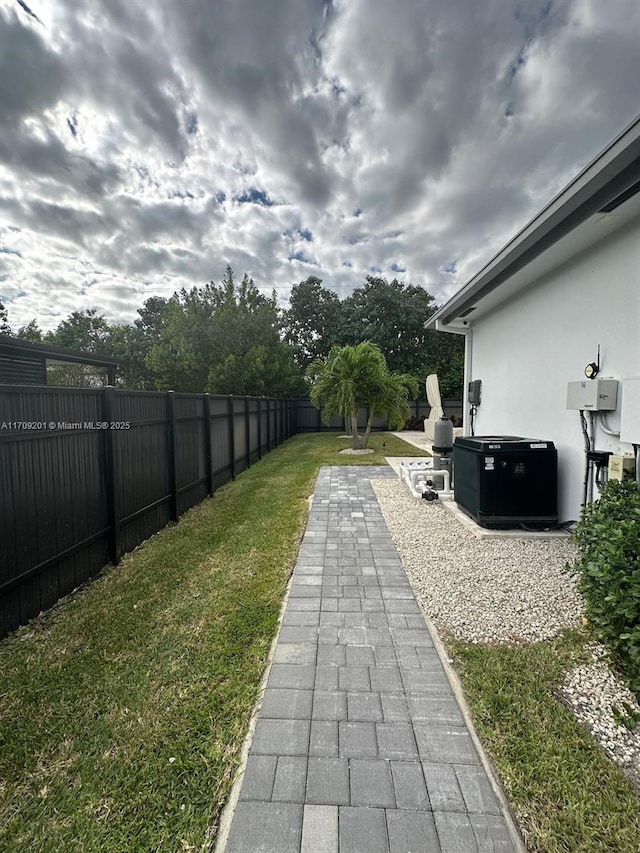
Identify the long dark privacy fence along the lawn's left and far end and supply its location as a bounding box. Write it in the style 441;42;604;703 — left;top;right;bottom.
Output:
0;385;455;637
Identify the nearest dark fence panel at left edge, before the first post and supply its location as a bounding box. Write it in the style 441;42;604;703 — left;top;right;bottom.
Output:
0;386;109;635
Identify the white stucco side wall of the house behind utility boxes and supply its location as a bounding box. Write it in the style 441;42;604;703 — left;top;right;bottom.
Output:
470;219;640;521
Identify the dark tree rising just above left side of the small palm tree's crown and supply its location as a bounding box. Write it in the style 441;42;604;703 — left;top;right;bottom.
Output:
284;275;342;369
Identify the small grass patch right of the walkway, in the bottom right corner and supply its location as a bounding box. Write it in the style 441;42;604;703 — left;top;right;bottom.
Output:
445;631;640;853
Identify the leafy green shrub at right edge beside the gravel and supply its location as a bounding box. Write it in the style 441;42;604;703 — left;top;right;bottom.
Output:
567;480;640;696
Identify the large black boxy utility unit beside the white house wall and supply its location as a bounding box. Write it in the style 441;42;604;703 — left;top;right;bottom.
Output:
453;435;558;528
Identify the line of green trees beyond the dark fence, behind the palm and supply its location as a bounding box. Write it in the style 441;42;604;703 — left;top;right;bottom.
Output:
0;267;464;397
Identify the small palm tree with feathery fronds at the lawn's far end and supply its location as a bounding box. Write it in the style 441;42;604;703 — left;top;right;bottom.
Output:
307;341;417;450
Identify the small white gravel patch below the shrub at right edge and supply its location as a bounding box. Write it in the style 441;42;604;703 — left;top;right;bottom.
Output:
560;644;640;790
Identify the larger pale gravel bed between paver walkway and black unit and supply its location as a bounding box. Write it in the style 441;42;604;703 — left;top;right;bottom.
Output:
372;480;582;643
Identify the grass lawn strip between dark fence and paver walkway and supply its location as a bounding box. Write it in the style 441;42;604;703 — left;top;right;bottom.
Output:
0;434;420;853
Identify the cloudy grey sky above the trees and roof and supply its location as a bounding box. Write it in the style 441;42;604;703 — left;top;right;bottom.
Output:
0;0;640;331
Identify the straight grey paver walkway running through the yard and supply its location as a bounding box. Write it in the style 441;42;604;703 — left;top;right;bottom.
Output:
220;466;516;853
